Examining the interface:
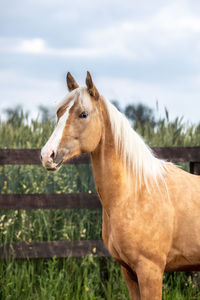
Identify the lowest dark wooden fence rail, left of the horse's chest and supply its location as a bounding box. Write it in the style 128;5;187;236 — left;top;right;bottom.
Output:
0;240;110;258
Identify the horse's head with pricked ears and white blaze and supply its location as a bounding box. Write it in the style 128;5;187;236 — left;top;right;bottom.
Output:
41;72;102;171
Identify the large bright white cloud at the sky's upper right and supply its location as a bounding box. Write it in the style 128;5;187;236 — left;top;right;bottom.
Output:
88;1;200;61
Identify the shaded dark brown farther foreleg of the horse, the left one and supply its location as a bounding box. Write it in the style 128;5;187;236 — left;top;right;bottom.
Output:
122;267;140;300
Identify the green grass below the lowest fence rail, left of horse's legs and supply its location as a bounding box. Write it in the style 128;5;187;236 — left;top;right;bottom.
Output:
0;256;128;300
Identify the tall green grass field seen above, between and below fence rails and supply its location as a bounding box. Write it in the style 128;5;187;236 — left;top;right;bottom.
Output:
0;111;200;300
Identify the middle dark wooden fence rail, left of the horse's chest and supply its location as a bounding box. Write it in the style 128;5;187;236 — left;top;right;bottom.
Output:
0;193;101;209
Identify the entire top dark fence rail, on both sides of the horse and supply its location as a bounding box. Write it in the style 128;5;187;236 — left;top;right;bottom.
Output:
0;147;200;165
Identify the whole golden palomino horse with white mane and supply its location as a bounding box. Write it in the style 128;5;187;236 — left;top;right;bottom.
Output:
41;72;200;300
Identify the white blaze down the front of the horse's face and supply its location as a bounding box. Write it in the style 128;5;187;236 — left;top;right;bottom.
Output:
41;100;74;158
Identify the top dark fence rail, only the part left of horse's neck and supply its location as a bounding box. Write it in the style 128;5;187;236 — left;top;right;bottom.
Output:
0;149;90;165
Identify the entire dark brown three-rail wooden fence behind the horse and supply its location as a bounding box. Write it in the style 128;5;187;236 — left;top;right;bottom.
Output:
0;147;200;258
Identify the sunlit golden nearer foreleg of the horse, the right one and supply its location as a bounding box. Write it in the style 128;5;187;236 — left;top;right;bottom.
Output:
136;259;164;300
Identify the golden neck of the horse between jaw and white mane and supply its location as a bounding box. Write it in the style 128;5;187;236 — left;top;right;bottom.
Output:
91;100;133;213
